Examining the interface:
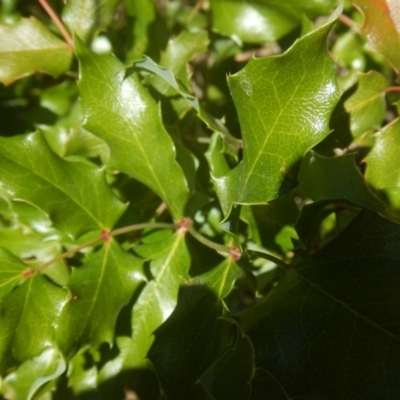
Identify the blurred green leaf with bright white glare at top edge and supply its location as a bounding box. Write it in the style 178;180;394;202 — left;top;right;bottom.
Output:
211;0;338;43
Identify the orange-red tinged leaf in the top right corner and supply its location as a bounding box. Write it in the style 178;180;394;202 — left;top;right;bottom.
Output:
354;0;400;72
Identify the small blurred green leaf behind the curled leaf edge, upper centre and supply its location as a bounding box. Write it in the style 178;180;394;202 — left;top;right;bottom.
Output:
152;31;209;96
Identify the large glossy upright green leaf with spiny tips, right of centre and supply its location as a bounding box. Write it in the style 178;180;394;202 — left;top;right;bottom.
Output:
217;9;340;212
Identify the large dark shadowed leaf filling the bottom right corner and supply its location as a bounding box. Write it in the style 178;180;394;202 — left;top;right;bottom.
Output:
240;211;400;399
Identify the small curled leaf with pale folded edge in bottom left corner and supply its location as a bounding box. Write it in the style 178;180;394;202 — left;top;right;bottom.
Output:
4;348;67;400
